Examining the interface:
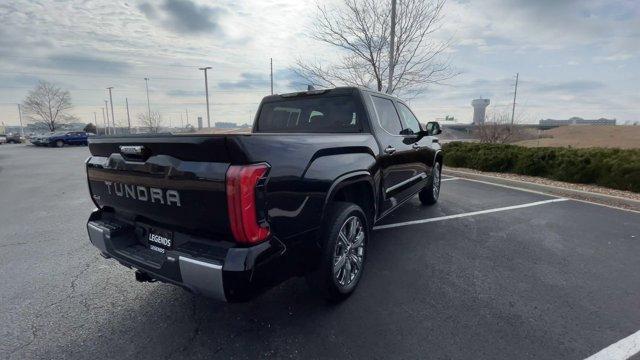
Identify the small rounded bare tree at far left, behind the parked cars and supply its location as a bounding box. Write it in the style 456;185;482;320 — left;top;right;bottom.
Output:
22;81;76;131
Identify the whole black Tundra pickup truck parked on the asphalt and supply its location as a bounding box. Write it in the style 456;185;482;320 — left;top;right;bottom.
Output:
86;87;442;302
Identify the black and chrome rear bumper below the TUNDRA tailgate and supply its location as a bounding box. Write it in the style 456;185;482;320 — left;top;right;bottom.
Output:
87;210;291;302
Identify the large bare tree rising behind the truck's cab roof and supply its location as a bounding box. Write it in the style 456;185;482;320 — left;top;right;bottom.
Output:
294;0;458;95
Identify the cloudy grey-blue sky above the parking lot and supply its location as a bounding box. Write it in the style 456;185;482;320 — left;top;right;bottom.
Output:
0;0;640;125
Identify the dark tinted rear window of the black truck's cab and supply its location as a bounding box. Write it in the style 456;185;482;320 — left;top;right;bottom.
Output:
256;96;363;133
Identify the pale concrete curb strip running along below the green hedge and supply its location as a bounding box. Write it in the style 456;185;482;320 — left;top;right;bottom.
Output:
443;168;640;212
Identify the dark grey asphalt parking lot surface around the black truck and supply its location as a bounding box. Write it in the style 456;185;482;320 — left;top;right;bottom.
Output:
0;145;640;359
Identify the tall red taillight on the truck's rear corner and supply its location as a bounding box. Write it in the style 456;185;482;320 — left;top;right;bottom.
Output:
227;164;269;244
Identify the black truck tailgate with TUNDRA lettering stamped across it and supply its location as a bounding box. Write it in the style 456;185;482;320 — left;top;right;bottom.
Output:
87;136;230;238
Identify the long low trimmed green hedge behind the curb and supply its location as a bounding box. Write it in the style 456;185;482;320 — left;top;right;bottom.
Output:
443;142;640;192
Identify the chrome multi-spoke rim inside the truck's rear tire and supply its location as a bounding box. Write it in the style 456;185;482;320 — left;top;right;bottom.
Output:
333;216;365;287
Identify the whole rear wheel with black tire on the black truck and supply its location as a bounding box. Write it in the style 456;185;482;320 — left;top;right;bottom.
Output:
307;202;369;302
